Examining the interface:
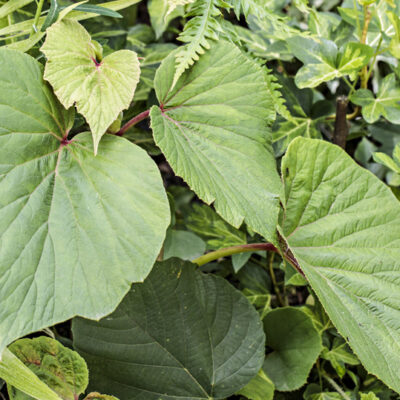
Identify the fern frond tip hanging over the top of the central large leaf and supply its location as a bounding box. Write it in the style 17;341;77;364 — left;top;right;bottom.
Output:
173;0;229;86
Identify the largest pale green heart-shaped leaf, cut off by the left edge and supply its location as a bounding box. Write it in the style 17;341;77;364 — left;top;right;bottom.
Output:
0;49;170;352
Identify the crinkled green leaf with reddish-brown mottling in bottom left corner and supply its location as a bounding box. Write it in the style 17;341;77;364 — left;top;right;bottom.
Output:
8;336;89;400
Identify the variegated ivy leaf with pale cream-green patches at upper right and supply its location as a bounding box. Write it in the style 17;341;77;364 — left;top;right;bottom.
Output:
288;36;373;88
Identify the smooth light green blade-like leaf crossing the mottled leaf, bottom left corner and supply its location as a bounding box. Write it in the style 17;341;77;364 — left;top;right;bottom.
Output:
0;349;60;400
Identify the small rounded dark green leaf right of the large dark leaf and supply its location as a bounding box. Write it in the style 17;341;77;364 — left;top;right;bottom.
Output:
263;307;322;391
